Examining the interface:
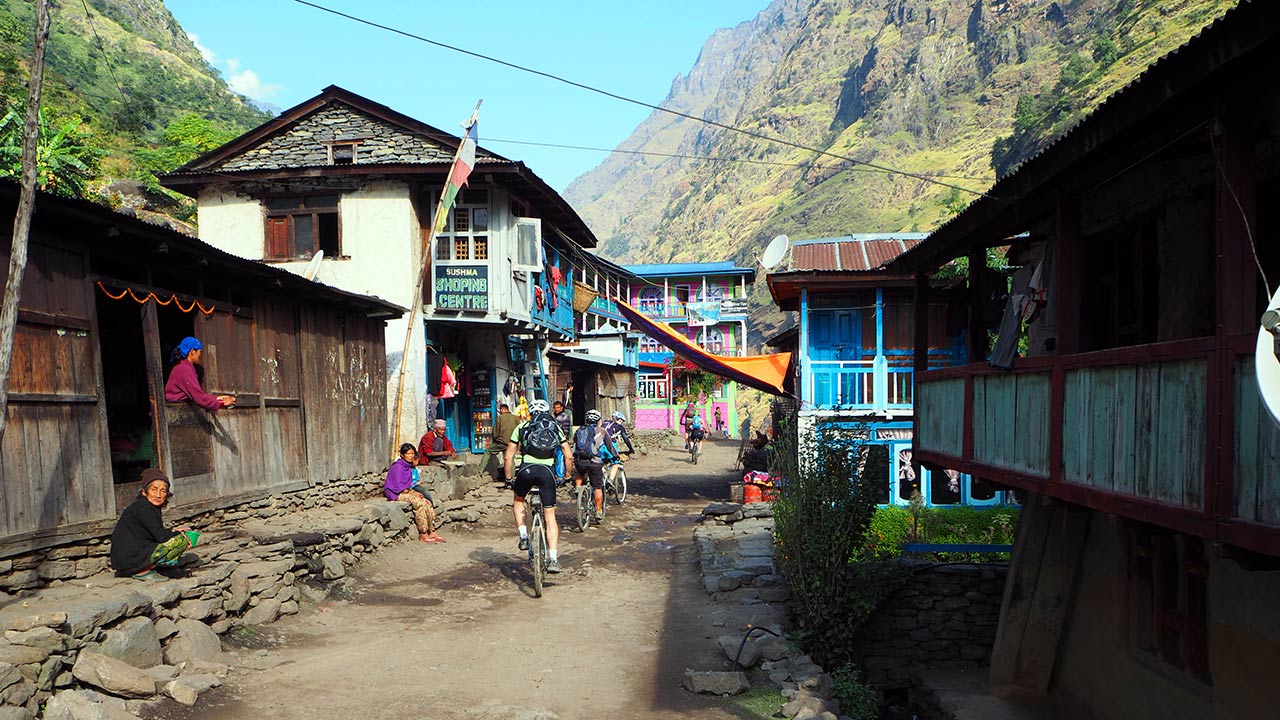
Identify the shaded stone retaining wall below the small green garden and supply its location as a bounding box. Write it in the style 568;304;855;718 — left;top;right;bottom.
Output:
855;560;1009;689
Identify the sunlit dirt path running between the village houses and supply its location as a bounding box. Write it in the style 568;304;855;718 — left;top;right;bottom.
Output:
157;441;778;720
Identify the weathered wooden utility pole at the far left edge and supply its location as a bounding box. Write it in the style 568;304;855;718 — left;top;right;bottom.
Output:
0;0;49;441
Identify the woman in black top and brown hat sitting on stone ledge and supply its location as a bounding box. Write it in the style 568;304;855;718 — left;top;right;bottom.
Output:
111;468;200;582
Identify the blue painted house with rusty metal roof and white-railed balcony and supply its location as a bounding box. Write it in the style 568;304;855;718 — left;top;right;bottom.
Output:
767;233;1006;505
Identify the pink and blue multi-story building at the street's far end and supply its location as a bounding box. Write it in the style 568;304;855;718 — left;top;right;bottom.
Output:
626;261;755;432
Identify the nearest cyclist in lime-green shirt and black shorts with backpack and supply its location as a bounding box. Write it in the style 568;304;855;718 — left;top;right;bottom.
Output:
506;400;573;573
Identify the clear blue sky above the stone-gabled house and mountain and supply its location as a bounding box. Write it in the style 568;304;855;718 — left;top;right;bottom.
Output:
165;0;768;191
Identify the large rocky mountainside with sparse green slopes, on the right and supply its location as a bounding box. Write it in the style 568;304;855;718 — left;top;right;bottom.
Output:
566;0;1235;333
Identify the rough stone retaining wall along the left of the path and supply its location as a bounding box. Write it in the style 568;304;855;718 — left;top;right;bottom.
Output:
0;466;504;720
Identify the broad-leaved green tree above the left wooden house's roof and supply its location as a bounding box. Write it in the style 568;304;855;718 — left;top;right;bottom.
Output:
0;109;102;197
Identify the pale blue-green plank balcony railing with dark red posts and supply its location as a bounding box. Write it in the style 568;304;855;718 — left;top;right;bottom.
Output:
915;336;1280;553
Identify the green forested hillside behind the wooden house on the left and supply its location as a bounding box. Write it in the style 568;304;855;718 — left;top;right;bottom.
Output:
0;0;270;219
